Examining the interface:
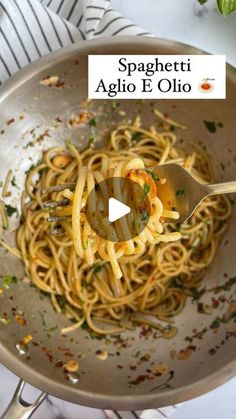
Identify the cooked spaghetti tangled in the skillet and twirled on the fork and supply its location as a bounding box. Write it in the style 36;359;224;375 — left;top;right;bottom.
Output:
14;117;230;337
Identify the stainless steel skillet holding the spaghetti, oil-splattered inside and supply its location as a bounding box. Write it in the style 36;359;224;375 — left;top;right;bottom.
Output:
0;38;236;417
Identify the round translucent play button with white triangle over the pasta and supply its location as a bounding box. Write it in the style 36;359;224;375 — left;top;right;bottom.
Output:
85;177;151;242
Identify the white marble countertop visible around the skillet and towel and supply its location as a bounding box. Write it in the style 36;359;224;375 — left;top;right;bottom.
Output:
0;0;236;419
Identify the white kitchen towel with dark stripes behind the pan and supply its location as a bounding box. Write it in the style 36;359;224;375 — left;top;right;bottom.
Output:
0;0;148;84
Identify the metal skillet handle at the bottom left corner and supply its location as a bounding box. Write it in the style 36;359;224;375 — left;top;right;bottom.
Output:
1;380;46;419
